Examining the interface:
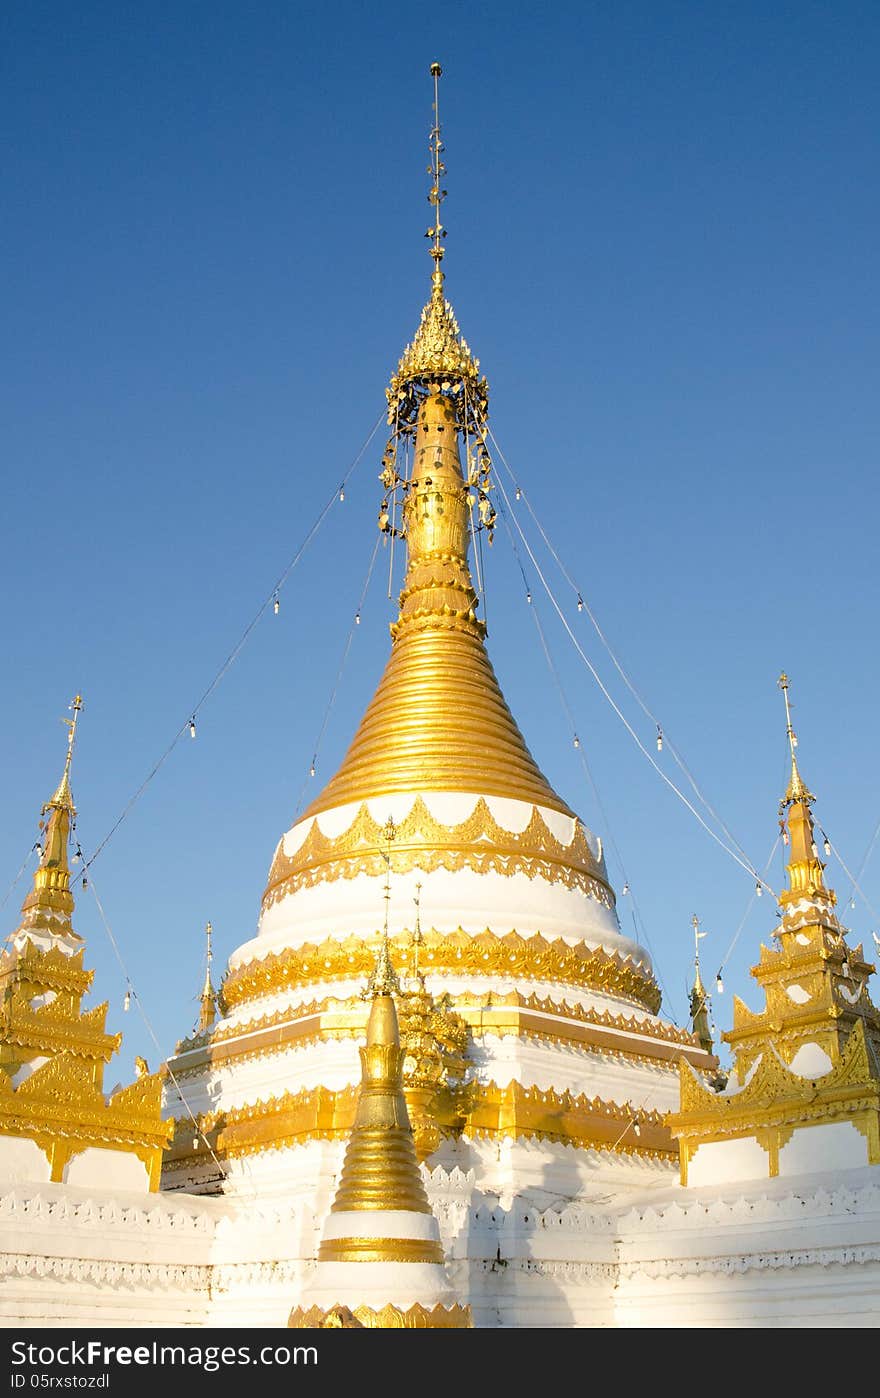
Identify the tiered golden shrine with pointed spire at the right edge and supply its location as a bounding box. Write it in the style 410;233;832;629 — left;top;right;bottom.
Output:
669;674;880;1184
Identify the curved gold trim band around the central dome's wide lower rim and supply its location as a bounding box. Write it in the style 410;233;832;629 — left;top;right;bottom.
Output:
222;928;662;1015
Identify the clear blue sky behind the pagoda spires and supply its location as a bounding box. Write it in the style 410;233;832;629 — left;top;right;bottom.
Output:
0;0;880;1085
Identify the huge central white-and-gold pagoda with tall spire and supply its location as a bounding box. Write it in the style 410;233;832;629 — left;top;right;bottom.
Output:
164;64;716;1235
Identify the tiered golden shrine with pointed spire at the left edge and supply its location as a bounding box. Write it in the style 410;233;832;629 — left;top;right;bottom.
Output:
0;695;173;1190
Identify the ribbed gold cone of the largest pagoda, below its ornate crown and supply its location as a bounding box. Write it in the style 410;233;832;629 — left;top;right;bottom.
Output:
304;394;574;819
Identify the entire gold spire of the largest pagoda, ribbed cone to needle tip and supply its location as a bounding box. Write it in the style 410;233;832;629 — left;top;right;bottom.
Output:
297;64;574;818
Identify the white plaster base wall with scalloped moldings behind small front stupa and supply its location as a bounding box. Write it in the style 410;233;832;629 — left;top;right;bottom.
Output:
0;1141;880;1329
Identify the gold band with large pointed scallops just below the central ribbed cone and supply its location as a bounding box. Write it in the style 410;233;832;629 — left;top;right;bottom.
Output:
263;797;604;910
